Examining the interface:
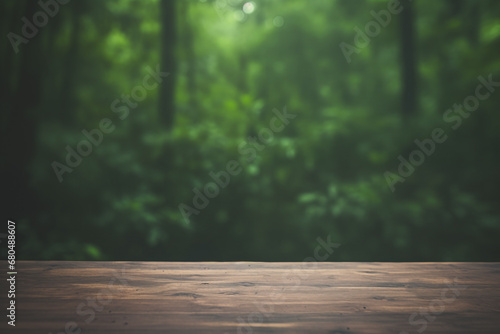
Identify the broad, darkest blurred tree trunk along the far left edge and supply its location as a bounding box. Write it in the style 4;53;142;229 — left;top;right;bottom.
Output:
1;1;45;221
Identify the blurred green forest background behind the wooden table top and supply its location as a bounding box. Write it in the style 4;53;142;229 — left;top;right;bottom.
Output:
0;0;500;261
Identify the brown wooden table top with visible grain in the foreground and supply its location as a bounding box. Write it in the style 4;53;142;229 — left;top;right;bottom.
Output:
0;261;500;334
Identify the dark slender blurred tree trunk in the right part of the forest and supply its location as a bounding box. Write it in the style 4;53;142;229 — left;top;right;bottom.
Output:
400;1;417;116
